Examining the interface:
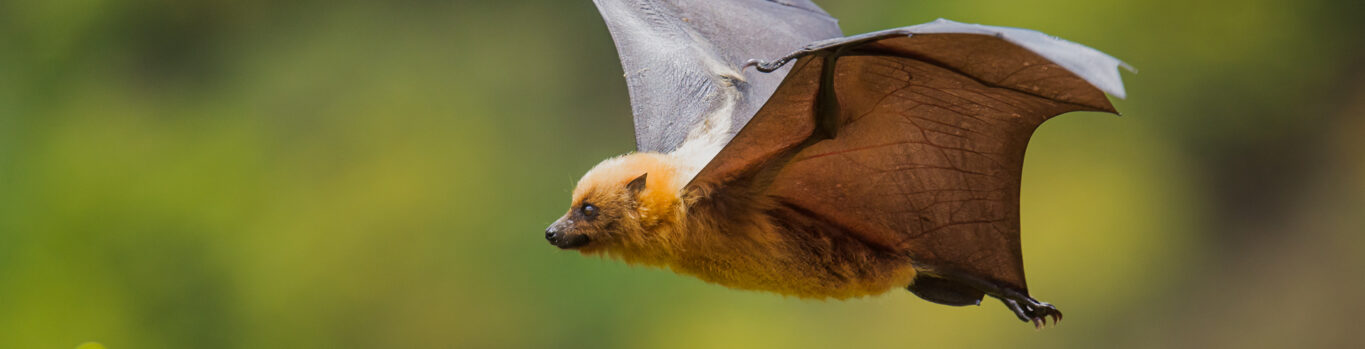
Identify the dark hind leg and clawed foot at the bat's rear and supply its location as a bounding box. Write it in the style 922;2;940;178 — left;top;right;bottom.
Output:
906;270;1062;329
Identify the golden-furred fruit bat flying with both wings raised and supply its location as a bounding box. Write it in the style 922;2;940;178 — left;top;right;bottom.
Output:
545;0;1123;327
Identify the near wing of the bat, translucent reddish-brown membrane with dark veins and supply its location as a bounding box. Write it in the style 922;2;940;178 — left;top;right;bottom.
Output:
689;20;1122;296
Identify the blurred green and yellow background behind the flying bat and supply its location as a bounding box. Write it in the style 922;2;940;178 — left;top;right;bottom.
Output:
0;0;1365;349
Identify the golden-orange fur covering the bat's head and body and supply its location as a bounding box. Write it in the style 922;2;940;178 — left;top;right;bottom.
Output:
566;153;916;299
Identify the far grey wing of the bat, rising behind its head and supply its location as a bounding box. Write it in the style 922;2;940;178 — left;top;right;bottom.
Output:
592;0;842;153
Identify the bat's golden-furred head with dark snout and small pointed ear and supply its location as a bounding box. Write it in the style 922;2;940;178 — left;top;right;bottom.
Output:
545;153;681;258
